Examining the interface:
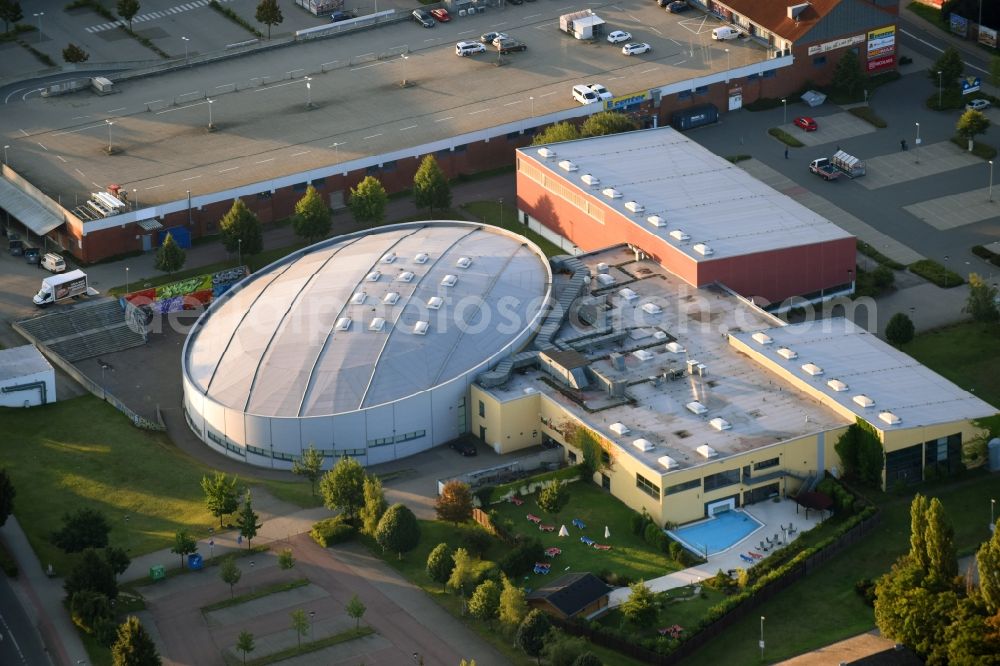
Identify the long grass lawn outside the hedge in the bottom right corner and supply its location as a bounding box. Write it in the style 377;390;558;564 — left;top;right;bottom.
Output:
686;472;996;666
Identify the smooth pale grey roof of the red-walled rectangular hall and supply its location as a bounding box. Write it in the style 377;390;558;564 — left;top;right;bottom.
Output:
519;127;851;261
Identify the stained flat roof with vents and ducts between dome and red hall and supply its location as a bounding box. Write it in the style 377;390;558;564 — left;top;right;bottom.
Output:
490;248;850;473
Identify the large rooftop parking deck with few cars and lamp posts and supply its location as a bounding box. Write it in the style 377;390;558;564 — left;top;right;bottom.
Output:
0;0;767;208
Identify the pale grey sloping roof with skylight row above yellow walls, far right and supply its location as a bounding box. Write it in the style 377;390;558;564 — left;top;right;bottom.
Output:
733;318;998;430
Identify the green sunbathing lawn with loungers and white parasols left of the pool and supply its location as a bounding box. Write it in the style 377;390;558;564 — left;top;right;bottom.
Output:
490;481;679;586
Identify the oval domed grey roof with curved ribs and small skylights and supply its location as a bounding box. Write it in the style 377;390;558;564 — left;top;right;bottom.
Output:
184;222;551;417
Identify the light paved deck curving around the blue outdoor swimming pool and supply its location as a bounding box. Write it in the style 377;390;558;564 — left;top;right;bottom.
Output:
608;499;820;608
